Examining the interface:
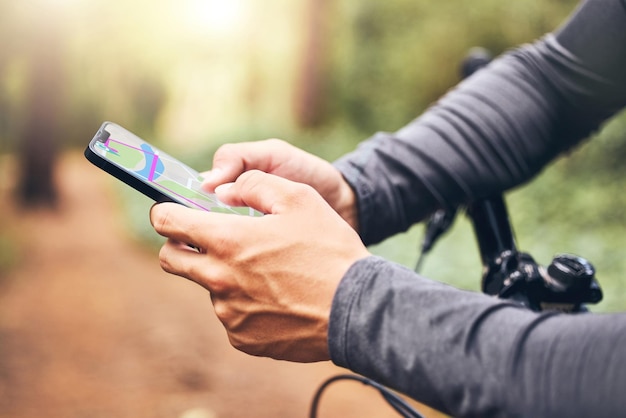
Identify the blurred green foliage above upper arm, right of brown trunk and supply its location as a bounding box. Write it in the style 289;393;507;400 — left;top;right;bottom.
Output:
328;0;576;133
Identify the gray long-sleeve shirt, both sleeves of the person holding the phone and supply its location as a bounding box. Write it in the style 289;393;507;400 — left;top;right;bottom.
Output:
328;0;626;417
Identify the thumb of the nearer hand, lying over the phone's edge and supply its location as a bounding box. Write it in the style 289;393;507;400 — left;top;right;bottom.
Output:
215;170;314;214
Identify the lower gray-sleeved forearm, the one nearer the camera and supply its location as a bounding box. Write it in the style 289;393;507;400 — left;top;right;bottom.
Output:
329;257;626;417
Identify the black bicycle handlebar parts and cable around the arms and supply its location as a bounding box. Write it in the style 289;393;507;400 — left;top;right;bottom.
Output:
309;48;602;418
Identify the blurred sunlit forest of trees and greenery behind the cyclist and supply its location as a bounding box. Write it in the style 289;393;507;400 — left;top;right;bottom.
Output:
0;0;626;311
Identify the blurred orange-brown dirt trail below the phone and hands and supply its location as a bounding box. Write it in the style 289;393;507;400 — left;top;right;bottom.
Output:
0;154;442;418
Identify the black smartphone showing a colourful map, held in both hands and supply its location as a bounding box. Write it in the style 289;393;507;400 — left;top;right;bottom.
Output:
85;122;262;216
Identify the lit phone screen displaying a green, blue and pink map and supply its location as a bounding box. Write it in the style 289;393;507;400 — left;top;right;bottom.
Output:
94;123;262;216
